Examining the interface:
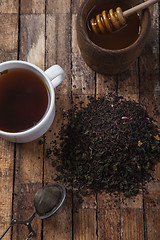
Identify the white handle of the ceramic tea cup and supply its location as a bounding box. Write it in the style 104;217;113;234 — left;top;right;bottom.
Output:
45;65;65;88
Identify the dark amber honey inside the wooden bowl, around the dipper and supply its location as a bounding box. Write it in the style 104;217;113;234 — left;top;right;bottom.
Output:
86;0;141;50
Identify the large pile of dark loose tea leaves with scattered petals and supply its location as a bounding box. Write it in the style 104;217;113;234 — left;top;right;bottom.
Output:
48;97;160;197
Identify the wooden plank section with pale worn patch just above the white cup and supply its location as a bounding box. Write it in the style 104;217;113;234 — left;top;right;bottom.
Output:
19;13;45;70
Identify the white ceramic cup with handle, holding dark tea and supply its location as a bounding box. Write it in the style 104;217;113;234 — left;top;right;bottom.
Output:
0;60;65;143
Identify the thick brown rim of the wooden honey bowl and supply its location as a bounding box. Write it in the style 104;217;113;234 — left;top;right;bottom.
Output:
77;0;151;54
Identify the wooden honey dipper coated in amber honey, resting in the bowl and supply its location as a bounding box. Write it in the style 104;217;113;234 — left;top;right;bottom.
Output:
90;0;160;34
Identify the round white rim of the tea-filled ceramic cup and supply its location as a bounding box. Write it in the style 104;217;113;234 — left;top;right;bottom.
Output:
0;60;55;137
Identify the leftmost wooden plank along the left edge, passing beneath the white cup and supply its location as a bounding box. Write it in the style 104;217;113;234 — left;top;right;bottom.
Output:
0;0;19;240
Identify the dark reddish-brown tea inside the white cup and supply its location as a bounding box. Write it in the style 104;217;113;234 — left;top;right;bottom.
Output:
0;68;50;132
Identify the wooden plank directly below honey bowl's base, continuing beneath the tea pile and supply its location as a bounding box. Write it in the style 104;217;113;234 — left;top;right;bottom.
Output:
96;35;121;240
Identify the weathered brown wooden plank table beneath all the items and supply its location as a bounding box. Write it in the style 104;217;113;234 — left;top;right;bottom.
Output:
0;0;160;240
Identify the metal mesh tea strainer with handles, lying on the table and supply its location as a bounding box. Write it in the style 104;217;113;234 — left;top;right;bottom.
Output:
0;183;66;240
